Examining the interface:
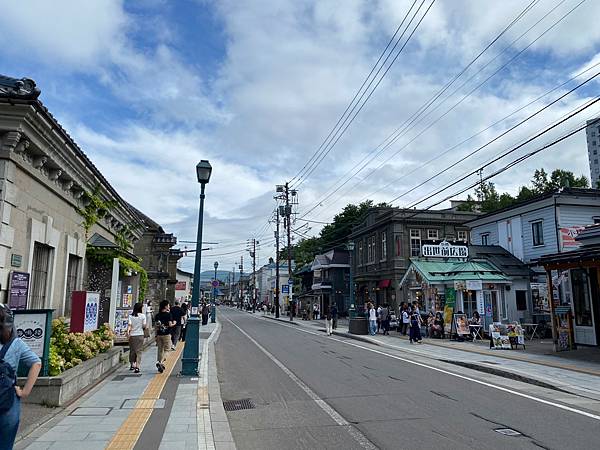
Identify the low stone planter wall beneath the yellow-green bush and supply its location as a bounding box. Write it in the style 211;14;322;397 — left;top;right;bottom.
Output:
18;347;123;406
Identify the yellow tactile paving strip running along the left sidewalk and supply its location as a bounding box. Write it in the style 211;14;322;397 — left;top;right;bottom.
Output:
106;342;184;450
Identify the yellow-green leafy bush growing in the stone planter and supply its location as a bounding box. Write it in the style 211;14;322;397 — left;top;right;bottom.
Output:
49;317;115;376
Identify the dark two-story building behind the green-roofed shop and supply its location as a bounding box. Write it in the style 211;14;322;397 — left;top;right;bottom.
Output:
349;207;479;308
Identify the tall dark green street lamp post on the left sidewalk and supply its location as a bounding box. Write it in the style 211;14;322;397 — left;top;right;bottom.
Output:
181;159;212;377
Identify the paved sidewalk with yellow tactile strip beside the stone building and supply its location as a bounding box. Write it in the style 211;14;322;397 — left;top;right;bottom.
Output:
15;324;235;450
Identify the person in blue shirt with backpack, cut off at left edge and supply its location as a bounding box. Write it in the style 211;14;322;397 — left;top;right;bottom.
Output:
0;304;42;450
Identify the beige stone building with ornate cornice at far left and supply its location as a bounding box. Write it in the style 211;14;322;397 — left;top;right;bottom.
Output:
0;76;143;316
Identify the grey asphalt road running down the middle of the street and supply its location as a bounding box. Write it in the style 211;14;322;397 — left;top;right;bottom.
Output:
216;308;600;450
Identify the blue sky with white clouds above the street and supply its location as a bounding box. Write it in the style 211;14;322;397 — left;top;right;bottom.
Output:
0;0;600;269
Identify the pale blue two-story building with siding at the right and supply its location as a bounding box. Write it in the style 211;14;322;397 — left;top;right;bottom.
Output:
467;188;600;345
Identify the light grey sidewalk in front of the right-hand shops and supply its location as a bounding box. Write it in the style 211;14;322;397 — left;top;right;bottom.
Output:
267;316;600;400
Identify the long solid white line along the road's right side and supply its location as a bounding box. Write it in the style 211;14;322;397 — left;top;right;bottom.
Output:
246;312;600;421
